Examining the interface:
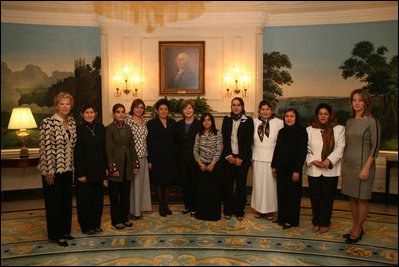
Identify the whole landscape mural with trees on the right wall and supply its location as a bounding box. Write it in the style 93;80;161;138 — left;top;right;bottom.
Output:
263;20;398;151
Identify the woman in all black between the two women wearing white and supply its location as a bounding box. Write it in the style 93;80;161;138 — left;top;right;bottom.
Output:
271;109;308;229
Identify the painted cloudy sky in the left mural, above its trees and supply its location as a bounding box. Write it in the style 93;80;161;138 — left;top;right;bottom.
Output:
1;23;101;76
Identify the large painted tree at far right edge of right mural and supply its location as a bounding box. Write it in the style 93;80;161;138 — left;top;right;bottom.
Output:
339;41;398;124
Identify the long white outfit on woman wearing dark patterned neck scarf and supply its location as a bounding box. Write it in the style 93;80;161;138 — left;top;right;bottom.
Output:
251;118;284;213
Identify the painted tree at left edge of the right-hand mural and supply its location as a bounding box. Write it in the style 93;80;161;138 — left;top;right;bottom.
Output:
263;51;294;103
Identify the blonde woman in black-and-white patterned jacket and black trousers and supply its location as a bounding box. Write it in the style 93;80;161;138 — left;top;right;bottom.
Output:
39;92;76;247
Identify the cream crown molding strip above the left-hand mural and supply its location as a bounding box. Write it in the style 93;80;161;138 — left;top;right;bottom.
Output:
1;9;99;26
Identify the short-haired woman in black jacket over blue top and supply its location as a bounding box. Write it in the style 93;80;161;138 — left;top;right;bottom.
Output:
176;100;201;216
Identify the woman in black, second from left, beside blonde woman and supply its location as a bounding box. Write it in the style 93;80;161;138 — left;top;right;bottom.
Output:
74;104;108;235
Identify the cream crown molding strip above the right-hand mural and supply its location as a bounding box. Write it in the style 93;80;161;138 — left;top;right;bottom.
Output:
265;7;398;27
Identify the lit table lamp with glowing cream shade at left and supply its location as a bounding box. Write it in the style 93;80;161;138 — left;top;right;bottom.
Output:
8;106;37;158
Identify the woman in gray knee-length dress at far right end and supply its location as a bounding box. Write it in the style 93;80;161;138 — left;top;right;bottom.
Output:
341;89;381;244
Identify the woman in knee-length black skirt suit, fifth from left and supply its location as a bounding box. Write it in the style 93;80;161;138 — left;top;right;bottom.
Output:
147;99;176;217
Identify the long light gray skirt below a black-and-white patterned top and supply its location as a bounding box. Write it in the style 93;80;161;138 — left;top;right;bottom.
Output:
129;158;152;216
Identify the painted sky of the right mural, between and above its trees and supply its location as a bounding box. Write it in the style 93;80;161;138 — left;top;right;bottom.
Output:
263;20;398;97
